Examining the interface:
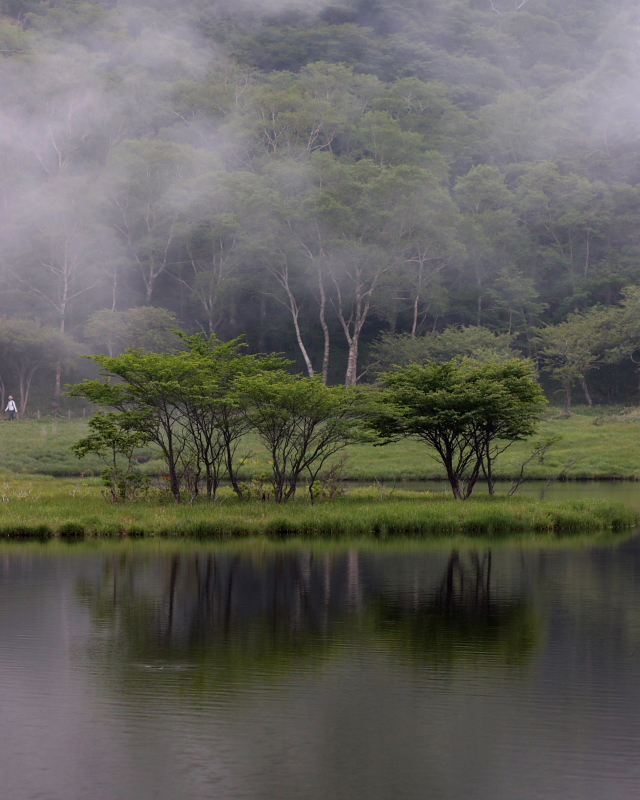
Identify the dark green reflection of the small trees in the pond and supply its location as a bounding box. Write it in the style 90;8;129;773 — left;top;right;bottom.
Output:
78;548;541;688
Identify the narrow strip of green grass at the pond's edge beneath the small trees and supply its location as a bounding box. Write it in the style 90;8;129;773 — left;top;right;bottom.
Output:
0;478;638;538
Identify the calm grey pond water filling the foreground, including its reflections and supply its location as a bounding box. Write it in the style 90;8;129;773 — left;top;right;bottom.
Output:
0;524;640;800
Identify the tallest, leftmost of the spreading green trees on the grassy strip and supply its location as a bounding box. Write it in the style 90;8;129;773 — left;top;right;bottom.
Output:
69;335;286;502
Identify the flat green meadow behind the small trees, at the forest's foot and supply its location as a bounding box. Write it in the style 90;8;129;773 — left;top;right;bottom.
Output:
0;408;640;481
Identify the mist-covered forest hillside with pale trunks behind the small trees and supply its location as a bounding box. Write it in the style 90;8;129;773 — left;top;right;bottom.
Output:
0;0;640;411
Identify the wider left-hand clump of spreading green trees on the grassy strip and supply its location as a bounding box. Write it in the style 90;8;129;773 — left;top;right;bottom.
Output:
69;334;364;503
